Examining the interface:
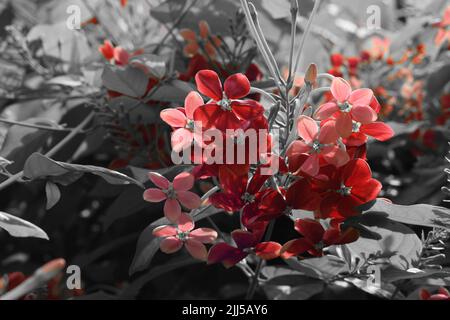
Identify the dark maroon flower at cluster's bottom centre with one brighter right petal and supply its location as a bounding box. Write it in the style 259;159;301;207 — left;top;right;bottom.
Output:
208;230;281;268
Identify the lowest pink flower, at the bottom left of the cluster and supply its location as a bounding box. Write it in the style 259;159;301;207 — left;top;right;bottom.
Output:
153;213;217;261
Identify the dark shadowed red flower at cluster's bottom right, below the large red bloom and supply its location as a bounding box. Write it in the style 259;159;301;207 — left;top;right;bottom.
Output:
280;219;359;259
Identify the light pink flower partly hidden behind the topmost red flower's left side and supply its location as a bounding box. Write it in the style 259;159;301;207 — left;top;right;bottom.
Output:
160;91;204;152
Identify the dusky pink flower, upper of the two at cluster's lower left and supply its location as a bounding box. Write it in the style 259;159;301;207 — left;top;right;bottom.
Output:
144;172;201;223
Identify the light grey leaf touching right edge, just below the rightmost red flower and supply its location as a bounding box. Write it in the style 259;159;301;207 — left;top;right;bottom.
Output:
361;199;450;229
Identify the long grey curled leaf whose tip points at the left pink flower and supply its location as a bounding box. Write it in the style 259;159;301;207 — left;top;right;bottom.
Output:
24;153;144;188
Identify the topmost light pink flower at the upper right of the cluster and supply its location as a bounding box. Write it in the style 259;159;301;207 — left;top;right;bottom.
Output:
314;78;377;138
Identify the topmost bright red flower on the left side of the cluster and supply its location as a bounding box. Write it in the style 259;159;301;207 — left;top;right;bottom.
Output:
194;70;264;131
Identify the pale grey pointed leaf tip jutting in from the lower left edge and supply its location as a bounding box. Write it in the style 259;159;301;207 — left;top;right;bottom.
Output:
0;212;48;240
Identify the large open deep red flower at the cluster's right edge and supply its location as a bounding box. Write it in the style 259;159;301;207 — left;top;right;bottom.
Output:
315;159;381;218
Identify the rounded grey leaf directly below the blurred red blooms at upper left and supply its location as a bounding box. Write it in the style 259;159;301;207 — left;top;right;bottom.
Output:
102;65;148;98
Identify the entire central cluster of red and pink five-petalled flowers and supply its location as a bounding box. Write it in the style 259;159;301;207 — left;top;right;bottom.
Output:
144;70;393;267
